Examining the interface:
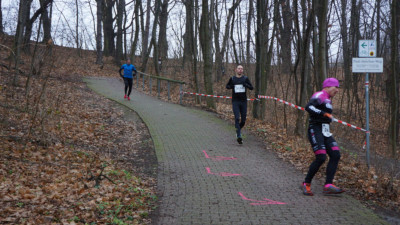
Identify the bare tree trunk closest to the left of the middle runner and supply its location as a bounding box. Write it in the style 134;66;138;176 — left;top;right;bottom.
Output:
200;0;216;109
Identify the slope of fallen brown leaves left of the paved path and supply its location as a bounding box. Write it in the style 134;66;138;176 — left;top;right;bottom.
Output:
0;35;157;224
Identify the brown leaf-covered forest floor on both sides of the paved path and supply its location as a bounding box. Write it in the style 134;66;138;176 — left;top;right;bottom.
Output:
0;33;400;224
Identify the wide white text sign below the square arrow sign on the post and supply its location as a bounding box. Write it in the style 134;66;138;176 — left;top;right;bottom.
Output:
352;58;383;73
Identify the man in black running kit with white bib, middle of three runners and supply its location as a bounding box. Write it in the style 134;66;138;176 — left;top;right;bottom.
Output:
226;65;253;144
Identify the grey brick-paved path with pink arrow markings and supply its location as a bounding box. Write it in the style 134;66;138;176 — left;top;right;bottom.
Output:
87;78;385;225
